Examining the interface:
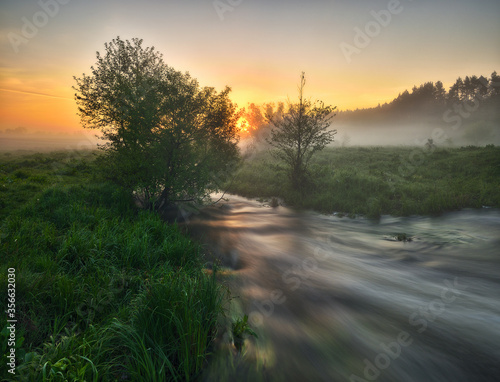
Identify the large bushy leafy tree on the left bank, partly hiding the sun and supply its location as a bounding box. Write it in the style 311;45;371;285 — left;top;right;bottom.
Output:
74;37;239;209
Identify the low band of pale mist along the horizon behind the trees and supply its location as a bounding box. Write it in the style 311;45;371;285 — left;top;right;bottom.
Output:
0;121;500;152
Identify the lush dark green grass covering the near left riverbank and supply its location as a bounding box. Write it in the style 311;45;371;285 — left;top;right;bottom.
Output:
0;152;225;381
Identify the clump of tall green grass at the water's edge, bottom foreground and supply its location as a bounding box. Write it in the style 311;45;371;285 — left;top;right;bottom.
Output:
110;272;223;381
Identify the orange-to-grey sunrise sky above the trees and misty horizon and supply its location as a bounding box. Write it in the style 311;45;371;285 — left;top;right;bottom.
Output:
0;0;500;135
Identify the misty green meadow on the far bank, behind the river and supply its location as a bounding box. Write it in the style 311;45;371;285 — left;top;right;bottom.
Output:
229;146;500;218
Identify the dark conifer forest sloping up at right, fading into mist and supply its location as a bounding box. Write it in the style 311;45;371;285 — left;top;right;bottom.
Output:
336;71;500;145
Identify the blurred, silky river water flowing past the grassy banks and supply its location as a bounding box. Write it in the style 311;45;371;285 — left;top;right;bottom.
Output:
184;196;500;382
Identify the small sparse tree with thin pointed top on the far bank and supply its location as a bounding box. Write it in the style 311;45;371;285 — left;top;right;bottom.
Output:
266;72;337;191
